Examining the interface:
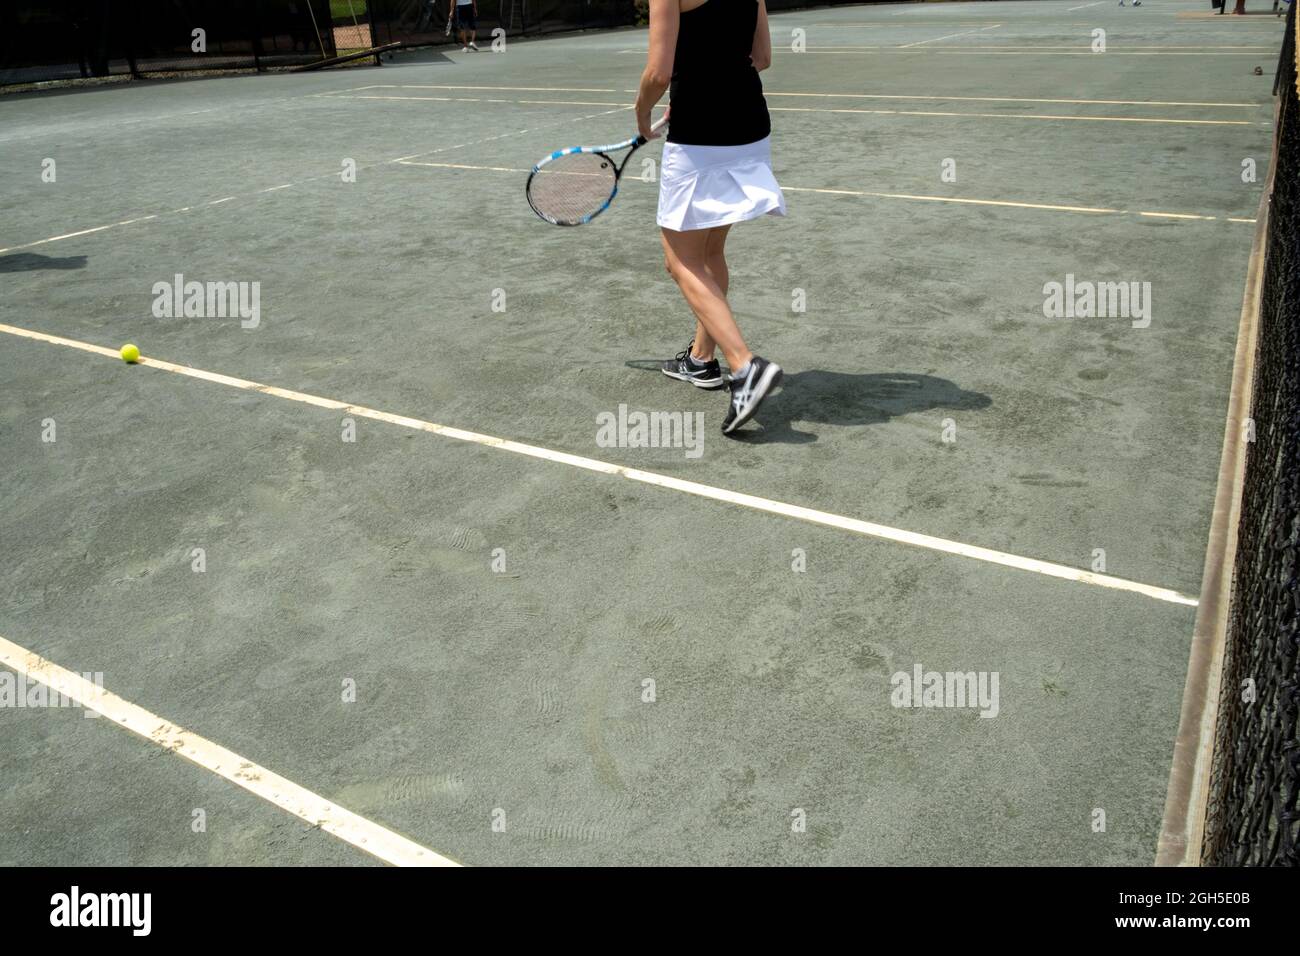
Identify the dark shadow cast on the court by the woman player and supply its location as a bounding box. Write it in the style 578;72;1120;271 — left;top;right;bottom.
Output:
628;362;993;445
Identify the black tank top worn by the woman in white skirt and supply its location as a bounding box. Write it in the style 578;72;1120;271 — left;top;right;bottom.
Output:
668;0;772;146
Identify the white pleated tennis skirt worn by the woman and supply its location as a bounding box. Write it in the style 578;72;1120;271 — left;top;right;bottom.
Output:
658;137;785;233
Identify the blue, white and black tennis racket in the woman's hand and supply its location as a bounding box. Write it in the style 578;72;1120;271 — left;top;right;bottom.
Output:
524;116;668;226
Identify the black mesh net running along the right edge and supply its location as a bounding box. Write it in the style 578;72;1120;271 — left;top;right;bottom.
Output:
1203;0;1300;866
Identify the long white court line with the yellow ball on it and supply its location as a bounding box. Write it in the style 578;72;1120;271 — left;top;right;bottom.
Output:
0;325;1196;607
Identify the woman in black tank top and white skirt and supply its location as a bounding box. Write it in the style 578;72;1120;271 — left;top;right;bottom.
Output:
637;0;785;434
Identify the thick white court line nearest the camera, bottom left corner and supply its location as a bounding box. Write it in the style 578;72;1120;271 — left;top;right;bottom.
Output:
0;636;460;866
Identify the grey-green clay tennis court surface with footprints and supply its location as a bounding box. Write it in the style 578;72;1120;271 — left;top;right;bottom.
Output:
0;0;1282;865
